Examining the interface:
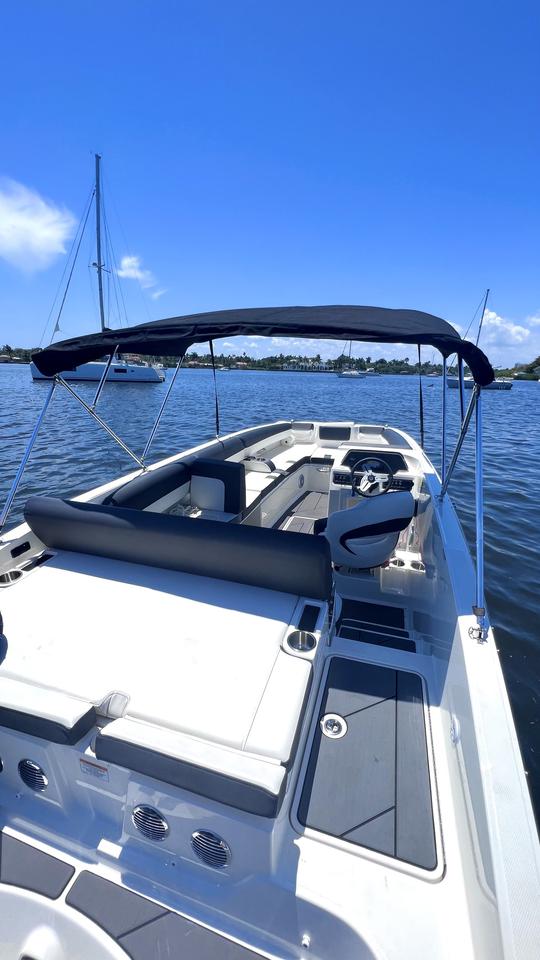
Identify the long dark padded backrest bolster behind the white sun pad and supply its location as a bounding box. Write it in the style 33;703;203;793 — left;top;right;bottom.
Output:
24;497;332;600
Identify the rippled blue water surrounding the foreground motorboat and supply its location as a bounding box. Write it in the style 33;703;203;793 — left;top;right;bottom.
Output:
0;365;540;813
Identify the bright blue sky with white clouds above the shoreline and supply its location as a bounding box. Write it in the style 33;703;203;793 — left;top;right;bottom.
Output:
0;0;540;364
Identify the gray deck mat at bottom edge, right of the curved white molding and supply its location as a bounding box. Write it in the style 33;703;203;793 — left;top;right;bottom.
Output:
66;870;261;960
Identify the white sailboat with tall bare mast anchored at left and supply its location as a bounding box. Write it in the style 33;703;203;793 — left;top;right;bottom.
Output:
30;153;165;383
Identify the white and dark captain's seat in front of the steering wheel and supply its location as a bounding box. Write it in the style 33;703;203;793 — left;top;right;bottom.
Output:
315;491;415;570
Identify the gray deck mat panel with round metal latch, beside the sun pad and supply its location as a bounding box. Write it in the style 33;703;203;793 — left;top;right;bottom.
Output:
298;657;437;870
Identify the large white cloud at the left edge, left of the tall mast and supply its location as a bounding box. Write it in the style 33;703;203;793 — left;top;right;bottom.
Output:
0;179;76;271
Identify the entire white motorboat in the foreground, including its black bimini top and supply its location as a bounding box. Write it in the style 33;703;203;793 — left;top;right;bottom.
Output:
0;307;540;960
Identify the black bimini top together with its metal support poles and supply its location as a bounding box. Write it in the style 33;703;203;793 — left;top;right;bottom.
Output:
0;306;494;640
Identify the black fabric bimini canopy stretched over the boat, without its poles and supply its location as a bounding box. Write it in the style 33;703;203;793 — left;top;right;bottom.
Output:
32;306;494;386
